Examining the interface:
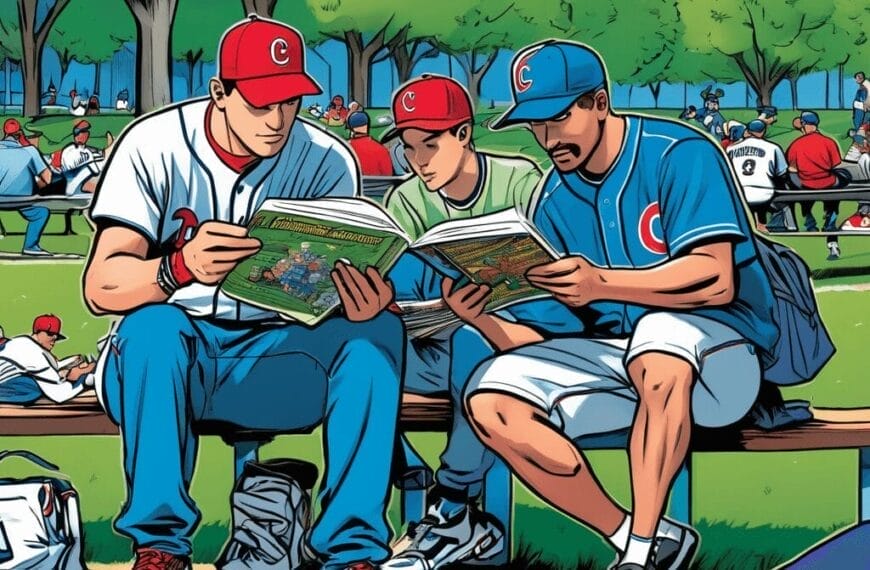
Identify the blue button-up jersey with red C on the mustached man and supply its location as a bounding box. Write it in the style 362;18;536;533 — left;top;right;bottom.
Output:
524;115;779;349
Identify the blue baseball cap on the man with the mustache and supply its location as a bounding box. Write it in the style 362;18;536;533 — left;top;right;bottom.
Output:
491;40;607;129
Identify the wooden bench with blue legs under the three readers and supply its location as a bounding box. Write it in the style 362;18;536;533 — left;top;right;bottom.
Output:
0;392;870;564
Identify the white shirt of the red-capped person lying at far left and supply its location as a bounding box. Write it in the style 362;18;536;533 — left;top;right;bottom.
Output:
0;335;84;402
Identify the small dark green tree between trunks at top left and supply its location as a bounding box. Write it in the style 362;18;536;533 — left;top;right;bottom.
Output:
48;0;136;95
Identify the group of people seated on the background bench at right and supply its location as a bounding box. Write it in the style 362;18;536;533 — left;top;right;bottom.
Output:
680;72;870;261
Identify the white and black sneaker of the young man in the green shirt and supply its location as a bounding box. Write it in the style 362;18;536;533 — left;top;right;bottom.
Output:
380;500;504;570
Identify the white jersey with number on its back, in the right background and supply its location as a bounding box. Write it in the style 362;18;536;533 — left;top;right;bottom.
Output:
726;137;788;204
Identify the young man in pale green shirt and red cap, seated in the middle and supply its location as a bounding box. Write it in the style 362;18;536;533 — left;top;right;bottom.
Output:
382;75;541;570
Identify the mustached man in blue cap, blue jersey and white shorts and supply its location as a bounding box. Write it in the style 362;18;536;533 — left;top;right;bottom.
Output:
446;41;778;570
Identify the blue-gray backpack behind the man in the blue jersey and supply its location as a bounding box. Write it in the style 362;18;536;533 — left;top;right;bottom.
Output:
755;235;836;386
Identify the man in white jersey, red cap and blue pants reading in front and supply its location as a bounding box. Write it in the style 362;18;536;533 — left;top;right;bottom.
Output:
84;16;403;570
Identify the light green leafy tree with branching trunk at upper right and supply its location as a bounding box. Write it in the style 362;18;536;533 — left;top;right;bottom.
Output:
677;0;837;105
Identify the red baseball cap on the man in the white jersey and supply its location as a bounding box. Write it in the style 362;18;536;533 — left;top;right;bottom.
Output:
218;14;323;107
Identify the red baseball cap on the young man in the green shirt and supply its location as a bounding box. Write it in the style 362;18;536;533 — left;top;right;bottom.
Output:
381;74;474;141
